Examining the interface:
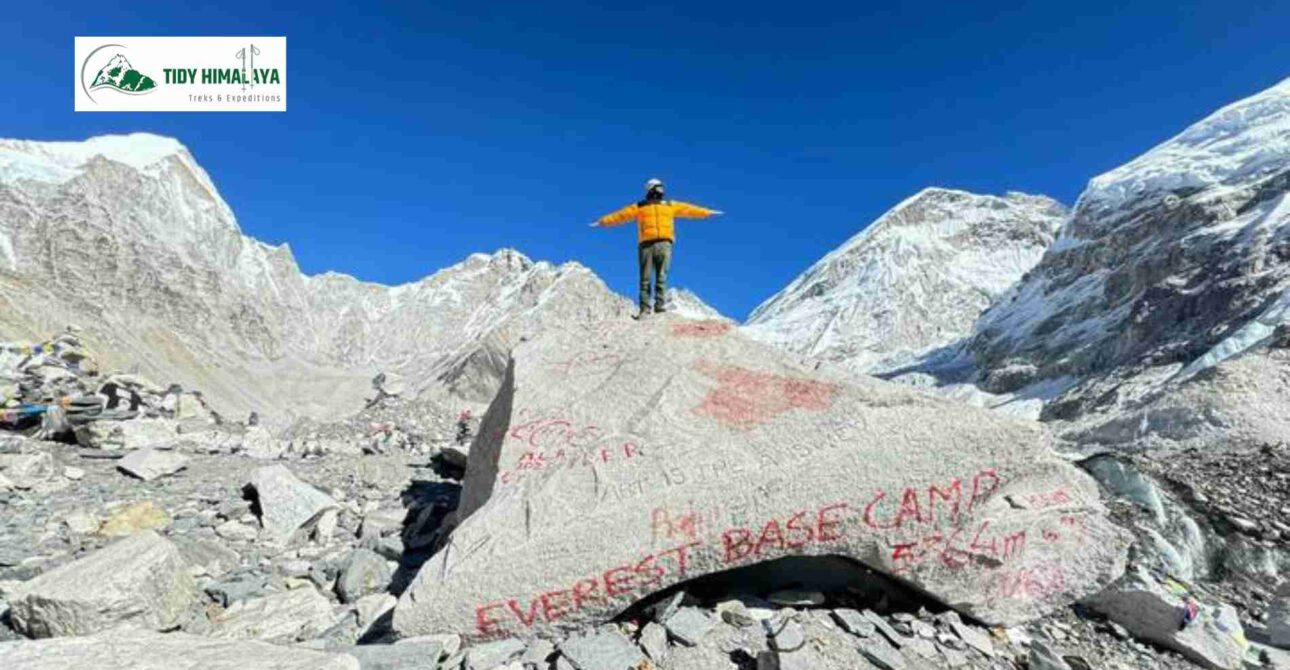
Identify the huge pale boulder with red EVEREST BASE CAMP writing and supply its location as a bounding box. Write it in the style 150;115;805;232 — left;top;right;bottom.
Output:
393;316;1129;639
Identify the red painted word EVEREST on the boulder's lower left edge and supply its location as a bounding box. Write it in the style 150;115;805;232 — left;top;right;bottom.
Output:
475;542;699;638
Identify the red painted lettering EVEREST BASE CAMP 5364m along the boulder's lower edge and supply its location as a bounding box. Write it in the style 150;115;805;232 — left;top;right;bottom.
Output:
476;467;1082;636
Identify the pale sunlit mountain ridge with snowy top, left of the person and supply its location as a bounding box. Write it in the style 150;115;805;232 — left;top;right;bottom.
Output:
0;134;630;421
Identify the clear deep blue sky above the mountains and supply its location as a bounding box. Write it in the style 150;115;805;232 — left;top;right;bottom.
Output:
0;0;1290;318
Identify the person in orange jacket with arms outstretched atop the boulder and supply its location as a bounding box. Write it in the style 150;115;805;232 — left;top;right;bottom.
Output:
591;179;721;319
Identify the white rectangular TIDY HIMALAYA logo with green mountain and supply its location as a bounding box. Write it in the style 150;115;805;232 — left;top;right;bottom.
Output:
75;36;286;111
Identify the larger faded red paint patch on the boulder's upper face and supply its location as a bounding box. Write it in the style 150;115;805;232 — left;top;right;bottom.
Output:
694;361;837;430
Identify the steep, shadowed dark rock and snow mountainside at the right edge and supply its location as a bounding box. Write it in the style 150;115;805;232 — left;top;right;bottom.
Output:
969;80;1290;446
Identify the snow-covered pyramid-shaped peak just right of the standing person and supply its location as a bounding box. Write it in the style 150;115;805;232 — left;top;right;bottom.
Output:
744;188;1066;372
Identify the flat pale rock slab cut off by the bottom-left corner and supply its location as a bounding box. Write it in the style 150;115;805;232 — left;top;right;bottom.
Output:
0;629;359;670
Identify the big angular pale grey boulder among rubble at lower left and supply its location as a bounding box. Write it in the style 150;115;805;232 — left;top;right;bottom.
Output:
9;531;199;638
